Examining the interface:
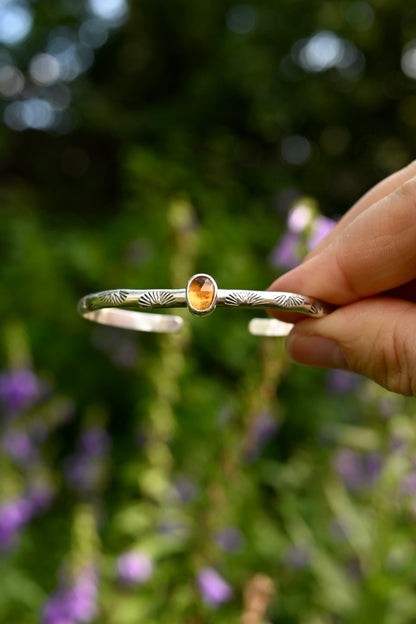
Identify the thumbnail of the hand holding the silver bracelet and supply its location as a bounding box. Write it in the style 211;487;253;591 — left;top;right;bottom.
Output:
286;333;348;368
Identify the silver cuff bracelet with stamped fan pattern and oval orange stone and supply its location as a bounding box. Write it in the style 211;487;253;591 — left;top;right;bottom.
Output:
78;273;333;336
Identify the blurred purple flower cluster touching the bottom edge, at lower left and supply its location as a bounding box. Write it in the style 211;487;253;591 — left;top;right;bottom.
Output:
43;566;98;624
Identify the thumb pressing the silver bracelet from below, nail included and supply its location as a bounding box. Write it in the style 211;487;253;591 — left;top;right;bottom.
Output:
286;297;416;396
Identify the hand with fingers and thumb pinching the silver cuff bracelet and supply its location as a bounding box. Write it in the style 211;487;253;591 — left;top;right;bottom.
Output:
270;161;416;396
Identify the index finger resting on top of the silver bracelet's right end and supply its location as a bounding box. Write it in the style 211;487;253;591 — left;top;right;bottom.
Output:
270;178;416;305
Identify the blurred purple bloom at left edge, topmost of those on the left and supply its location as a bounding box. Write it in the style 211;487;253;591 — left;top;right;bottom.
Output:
0;368;45;413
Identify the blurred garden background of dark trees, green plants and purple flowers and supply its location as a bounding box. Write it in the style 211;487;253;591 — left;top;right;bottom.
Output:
0;0;416;624
